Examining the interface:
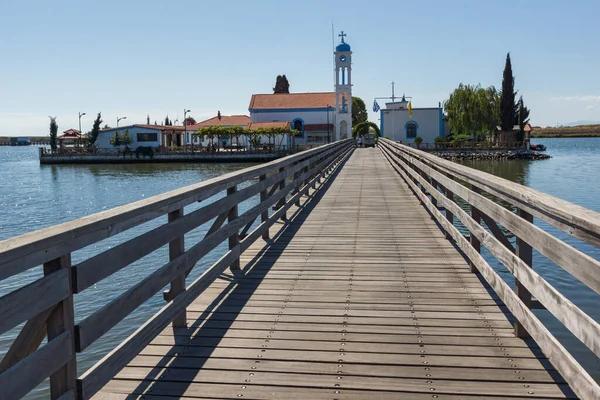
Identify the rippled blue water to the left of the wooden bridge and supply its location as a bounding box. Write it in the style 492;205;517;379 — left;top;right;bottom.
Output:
0;146;256;399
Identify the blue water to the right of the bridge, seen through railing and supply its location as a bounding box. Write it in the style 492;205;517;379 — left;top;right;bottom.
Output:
464;138;600;382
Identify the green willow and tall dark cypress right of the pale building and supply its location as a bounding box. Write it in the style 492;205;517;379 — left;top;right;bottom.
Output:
444;53;530;142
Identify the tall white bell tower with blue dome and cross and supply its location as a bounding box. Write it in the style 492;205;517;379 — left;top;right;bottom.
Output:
334;31;352;139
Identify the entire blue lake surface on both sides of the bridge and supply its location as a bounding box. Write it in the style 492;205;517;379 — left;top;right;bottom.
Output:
0;138;600;398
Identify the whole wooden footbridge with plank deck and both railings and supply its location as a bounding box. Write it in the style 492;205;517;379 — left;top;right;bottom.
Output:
0;139;600;400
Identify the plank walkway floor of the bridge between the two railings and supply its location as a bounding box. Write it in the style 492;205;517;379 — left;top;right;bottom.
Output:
96;149;574;400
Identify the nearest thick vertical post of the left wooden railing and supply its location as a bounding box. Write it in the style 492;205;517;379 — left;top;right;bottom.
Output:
44;253;77;400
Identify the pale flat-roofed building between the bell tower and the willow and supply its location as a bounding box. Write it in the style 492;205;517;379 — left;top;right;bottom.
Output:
380;99;444;143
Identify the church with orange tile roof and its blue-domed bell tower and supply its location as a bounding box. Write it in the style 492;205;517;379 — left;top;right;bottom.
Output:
248;31;352;144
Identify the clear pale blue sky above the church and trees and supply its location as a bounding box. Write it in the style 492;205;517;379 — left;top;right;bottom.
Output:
0;0;600;136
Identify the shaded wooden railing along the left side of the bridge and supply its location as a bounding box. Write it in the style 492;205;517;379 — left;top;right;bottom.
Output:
0;140;354;400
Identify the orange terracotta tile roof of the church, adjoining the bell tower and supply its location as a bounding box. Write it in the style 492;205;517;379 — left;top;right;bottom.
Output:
248;92;335;110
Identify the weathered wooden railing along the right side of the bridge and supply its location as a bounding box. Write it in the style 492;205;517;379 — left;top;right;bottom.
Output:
379;139;600;399
